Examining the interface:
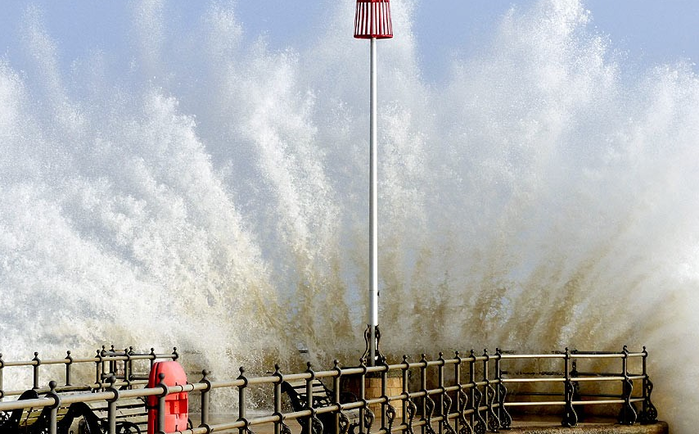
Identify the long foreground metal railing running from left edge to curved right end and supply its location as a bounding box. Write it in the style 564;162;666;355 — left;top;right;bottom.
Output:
0;347;657;434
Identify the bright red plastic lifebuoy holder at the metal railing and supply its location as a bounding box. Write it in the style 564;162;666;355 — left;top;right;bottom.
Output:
146;361;189;434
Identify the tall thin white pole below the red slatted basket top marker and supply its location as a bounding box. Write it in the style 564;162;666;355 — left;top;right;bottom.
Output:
369;38;379;366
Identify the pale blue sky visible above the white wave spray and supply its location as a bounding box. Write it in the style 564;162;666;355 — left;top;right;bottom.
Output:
0;0;699;80
